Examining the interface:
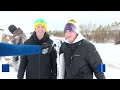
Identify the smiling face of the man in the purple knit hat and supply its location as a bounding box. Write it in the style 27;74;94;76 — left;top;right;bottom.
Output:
65;30;77;43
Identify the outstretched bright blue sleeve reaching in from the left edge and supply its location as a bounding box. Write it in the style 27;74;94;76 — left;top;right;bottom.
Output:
0;42;41;56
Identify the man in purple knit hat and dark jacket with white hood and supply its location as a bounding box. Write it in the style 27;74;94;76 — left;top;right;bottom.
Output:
60;20;105;79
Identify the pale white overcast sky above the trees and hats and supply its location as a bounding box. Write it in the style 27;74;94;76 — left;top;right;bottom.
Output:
0;11;120;33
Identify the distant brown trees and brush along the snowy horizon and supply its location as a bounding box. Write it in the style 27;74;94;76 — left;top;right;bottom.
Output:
48;22;120;44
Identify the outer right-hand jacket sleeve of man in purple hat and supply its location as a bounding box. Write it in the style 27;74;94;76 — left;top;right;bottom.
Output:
87;44;105;79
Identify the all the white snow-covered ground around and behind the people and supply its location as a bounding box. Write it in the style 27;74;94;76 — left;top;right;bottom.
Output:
0;36;120;79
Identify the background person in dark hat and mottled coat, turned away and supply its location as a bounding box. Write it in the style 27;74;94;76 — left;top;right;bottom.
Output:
8;25;27;71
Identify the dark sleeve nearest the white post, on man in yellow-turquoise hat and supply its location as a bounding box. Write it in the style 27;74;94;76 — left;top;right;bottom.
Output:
50;48;57;79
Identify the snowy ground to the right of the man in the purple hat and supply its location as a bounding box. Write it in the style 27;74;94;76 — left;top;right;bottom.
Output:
94;43;120;79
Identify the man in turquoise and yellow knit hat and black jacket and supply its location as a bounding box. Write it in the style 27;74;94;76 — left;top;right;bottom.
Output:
17;19;57;79
